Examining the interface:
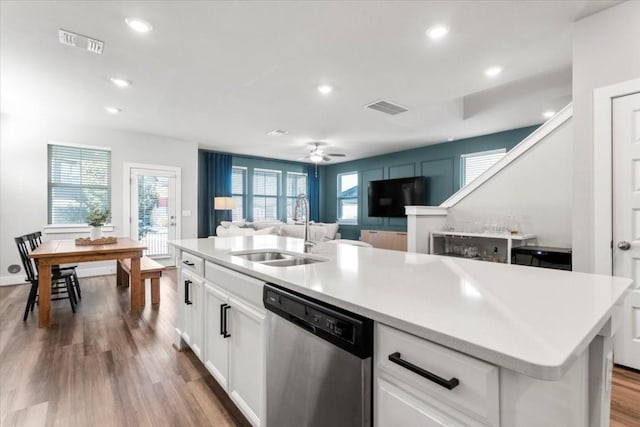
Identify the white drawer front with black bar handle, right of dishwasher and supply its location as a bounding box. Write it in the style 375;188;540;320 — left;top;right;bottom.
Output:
374;323;500;426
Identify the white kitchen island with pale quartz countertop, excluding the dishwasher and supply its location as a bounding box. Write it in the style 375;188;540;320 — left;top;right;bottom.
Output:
171;236;631;426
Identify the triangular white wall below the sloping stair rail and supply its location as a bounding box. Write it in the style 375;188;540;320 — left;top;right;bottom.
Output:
448;120;573;247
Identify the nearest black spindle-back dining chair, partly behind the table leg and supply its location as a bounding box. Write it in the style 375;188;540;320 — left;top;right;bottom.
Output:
14;234;77;321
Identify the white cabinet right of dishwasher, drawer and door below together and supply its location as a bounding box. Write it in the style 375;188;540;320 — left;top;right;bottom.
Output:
374;323;500;427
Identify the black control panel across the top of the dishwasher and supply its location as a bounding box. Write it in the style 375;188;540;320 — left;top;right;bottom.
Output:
263;284;373;358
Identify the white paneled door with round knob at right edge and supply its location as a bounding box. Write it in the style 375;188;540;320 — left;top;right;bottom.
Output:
612;93;640;369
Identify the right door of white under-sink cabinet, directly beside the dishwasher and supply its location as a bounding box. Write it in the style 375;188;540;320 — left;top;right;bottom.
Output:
229;297;266;426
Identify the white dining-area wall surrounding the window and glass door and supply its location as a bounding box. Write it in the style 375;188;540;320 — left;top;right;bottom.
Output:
0;115;198;284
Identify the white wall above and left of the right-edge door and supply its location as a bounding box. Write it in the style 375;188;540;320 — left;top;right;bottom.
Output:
572;1;640;272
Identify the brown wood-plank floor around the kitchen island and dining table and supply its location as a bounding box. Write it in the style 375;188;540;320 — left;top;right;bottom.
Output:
0;270;640;427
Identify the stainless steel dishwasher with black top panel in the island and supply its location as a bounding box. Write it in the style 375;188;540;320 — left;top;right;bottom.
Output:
263;284;373;427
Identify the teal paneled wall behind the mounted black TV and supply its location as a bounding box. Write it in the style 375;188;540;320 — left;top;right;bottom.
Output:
319;125;539;239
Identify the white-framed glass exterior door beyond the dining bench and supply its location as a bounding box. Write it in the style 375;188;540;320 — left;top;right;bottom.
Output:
129;167;179;265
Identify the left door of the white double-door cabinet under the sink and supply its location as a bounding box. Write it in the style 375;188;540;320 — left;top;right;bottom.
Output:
204;282;229;391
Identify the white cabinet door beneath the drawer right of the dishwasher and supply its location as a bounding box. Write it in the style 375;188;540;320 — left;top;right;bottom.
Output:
373;378;482;427
